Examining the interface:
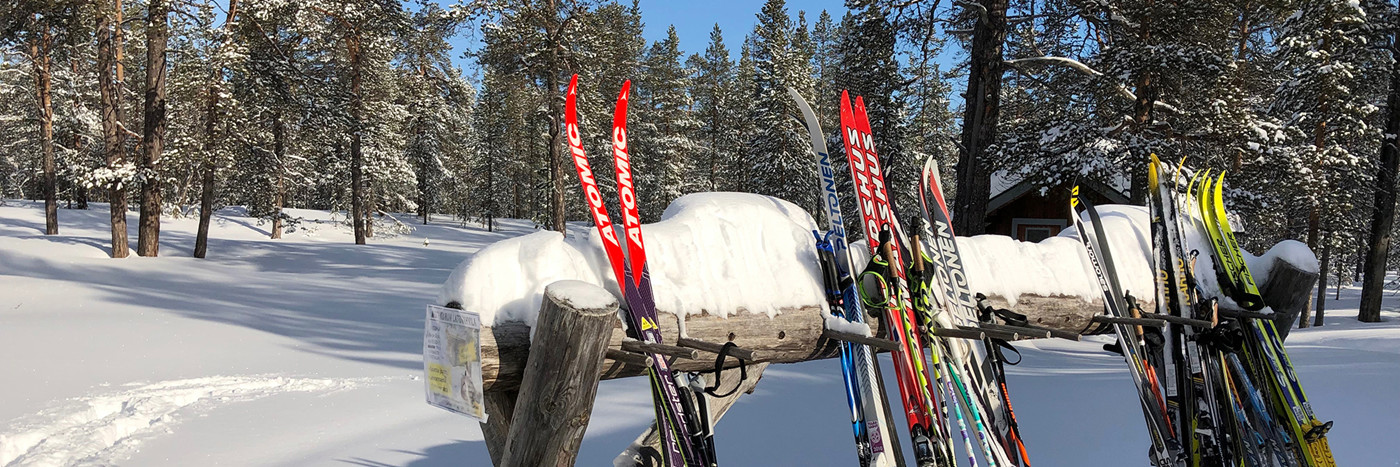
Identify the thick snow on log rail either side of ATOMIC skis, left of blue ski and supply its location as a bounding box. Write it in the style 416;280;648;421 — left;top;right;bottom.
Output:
438;193;825;324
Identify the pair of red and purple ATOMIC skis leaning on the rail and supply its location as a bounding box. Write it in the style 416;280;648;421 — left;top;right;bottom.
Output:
564;74;717;467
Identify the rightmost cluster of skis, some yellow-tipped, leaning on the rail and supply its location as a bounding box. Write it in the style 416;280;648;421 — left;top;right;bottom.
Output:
1070;155;1336;467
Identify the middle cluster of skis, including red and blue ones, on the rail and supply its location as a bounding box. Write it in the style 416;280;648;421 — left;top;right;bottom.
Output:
788;89;1036;467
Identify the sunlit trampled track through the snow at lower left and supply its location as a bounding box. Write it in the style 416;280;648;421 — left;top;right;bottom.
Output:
0;375;370;467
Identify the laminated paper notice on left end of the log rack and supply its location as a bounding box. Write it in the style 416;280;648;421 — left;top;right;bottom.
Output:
423;305;486;422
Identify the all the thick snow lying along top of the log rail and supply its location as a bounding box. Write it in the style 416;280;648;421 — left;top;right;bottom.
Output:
438;193;1317;331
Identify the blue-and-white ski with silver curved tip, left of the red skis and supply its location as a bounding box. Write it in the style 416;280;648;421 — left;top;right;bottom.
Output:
788;88;903;467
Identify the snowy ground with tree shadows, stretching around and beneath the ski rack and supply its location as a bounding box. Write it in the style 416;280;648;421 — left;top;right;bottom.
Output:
0;200;1400;467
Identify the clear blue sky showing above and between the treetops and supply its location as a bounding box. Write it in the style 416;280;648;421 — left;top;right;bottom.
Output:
442;0;846;74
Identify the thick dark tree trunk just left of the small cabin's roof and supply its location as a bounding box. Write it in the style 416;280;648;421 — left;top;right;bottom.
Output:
953;0;1008;236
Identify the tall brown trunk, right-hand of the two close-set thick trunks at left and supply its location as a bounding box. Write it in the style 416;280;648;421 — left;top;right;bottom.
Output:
136;0;169;256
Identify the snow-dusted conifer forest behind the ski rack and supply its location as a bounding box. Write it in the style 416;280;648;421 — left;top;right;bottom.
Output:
0;0;1400;324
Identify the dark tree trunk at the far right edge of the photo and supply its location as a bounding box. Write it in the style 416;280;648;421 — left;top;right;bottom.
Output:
1357;36;1400;323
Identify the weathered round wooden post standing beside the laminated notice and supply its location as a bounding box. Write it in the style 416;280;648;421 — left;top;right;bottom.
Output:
493;281;617;467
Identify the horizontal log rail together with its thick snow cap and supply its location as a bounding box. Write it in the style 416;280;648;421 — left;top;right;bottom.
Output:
438;193;1317;389
